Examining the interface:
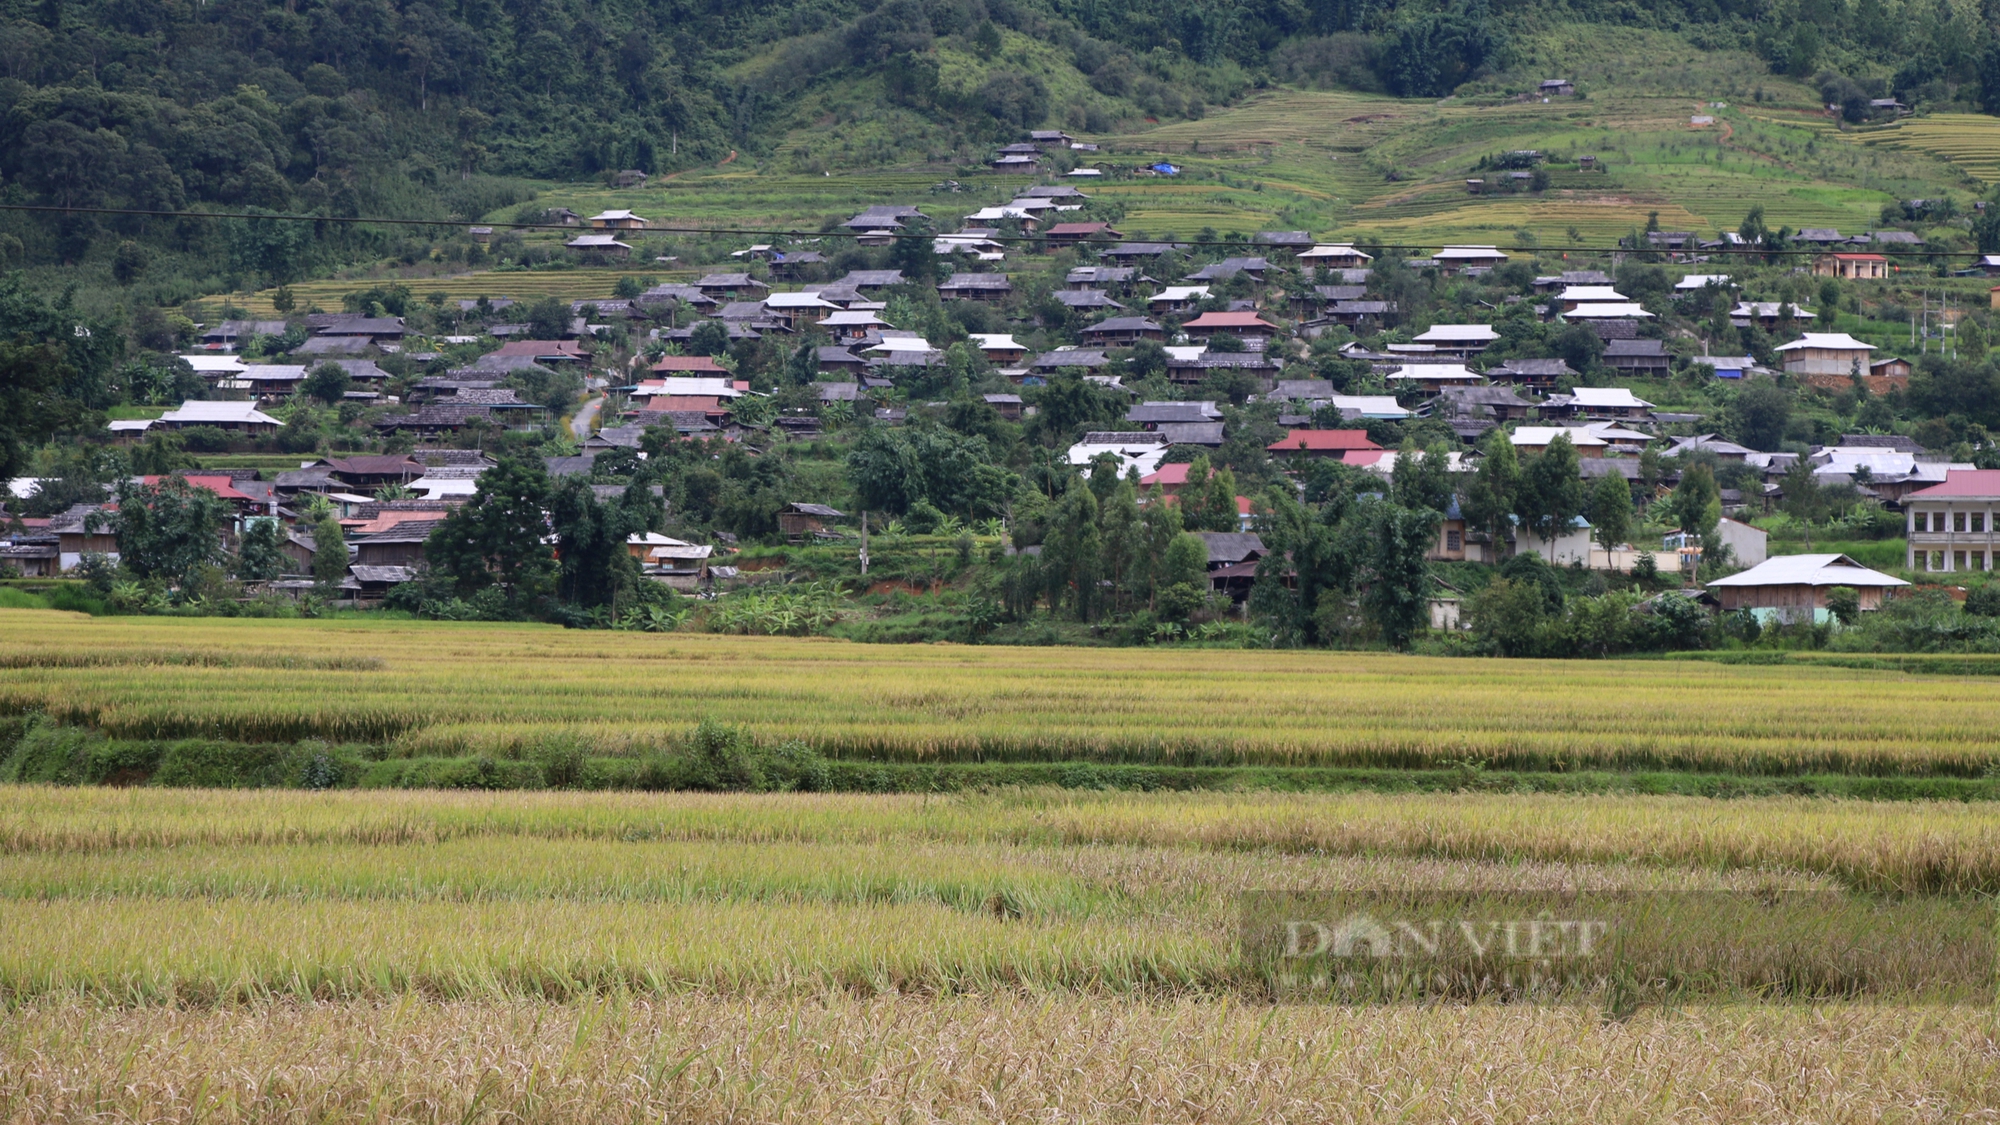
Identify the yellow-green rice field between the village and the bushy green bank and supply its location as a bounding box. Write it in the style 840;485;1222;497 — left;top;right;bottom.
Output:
0;611;2000;777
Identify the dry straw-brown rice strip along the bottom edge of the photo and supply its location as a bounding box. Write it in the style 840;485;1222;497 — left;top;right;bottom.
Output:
0;993;2000;1125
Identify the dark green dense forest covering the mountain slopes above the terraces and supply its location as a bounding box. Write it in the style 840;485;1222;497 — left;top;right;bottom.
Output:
0;0;2000;284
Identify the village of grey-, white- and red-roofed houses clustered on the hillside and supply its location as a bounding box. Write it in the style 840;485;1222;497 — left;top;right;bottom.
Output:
0;130;2000;644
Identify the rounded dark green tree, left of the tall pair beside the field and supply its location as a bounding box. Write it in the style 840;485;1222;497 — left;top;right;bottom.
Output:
424;458;556;607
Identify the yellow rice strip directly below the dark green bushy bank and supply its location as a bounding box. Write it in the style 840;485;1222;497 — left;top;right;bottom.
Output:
0;787;2000;888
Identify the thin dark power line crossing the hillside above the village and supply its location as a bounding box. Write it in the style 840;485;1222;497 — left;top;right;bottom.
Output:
0;202;1984;258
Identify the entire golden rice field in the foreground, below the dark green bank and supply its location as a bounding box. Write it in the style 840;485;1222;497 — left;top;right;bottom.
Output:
0;789;2000;1123
